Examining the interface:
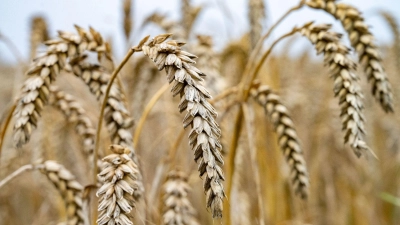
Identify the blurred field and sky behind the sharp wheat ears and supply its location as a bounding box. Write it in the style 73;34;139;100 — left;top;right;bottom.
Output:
0;0;400;225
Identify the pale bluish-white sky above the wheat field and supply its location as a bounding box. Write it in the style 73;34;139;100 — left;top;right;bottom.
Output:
0;0;400;63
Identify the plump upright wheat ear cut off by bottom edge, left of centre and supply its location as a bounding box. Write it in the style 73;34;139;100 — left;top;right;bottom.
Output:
96;145;139;225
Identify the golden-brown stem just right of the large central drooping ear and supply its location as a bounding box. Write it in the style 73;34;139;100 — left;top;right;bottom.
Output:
224;107;243;225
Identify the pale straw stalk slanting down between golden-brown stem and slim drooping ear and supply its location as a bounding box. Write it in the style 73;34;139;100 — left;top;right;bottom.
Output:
242;103;265;225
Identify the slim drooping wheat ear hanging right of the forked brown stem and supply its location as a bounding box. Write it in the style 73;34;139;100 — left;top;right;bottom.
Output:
250;84;310;198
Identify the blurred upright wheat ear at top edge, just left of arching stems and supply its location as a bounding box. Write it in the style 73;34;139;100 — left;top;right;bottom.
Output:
248;0;265;49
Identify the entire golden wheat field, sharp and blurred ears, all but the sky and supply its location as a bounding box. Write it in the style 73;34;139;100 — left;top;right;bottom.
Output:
0;0;400;225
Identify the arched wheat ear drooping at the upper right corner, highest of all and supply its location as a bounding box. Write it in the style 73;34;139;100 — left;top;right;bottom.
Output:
307;0;393;112
